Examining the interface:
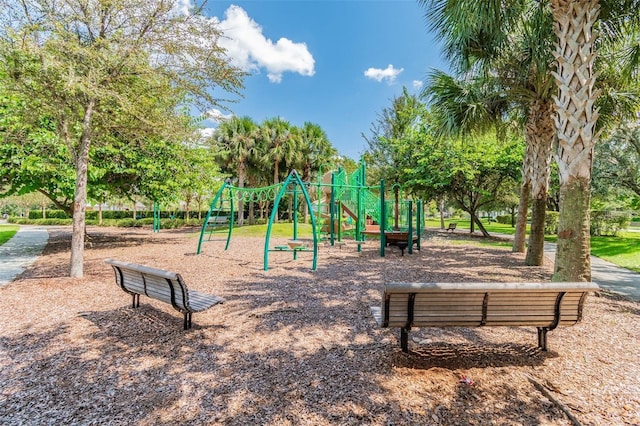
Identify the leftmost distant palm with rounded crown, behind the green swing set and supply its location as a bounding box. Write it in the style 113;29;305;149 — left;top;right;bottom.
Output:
213;116;258;226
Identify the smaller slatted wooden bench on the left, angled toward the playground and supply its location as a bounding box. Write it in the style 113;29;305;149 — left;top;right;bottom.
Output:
105;259;224;330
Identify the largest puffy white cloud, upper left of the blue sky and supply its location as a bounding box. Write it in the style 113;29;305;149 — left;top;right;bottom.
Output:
219;5;315;83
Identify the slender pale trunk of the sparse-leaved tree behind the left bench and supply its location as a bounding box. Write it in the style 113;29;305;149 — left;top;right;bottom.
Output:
69;99;95;278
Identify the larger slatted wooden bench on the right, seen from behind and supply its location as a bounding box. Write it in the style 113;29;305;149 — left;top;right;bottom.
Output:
371;282;599;352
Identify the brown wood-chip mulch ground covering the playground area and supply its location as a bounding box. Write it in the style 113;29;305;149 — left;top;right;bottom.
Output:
0;227;640;425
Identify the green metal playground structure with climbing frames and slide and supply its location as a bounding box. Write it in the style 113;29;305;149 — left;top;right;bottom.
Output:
197;162;424;271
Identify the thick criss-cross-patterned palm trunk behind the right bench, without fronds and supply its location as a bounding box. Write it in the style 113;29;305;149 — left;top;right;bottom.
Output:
551;0;600;281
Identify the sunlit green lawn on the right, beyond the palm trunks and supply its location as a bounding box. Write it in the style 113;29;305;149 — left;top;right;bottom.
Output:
426;219;640;273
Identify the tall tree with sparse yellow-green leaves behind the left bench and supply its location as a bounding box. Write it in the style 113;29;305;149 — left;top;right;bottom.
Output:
0;0;241;277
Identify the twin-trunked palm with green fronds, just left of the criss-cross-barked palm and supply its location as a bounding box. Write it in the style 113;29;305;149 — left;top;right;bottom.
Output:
424;3;555;265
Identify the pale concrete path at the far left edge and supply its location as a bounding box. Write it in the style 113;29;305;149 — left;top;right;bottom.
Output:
0;225;49;287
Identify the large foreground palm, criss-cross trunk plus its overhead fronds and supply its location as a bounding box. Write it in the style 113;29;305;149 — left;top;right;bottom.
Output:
420;0;640;281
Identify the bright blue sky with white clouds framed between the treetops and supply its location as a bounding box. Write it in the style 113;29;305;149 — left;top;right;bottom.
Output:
206;0;446;160
